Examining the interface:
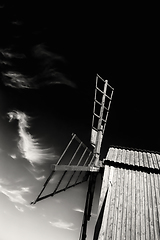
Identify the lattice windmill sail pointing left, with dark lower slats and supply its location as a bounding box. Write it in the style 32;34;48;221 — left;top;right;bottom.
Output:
31;134;99;204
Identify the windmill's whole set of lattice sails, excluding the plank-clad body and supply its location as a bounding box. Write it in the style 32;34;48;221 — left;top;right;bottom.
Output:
31;74;114;240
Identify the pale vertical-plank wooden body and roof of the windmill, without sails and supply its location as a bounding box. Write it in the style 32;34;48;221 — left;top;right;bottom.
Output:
94;147;160;240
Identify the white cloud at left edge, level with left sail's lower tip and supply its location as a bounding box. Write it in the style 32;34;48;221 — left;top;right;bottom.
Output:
0;185;27;205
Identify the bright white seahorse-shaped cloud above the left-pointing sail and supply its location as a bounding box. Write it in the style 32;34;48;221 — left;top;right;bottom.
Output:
8;111;56;166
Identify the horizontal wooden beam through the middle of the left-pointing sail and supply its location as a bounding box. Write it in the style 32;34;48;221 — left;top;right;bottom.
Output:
51;164;100;172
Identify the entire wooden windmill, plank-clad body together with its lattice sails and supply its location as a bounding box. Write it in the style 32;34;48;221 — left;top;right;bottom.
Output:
31;74;160;240
